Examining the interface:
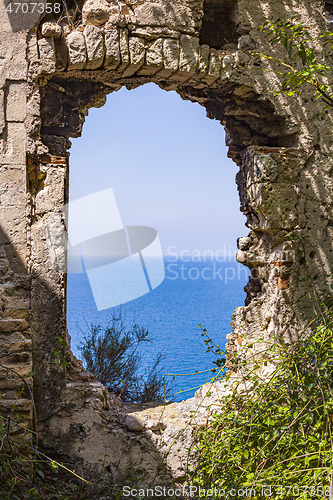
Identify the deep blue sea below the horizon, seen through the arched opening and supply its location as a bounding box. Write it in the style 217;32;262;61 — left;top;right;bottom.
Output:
67;258;249;401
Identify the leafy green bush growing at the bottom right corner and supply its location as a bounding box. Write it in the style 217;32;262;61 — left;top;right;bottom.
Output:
190;300;333;499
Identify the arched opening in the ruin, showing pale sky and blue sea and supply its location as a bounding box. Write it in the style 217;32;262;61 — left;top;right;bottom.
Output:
67;84;248;400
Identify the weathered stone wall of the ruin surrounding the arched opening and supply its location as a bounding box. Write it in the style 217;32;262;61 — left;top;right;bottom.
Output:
0;0;333;492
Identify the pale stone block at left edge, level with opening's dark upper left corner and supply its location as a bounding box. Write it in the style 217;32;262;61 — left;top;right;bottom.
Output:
0;122;26;165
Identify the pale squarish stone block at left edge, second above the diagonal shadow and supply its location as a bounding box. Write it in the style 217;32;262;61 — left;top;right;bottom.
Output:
0;165;27;207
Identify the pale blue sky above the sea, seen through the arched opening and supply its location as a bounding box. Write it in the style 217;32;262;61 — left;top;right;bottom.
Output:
70;83;248;256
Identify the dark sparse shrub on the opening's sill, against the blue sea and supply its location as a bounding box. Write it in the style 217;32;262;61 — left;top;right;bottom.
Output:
79;310;172;403
